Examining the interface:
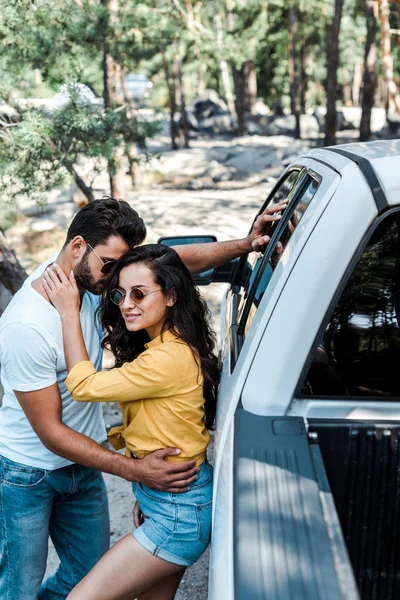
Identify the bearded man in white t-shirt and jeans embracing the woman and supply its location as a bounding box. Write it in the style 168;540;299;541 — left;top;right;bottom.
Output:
0;198;280;600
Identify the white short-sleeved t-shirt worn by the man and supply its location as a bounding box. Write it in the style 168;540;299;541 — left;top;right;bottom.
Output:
0;255;106;470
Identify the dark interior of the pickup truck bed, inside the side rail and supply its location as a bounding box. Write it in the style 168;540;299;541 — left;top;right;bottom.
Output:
308;419;400;600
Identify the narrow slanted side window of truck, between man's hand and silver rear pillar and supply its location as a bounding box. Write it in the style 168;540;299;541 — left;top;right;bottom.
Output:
241;172;321;337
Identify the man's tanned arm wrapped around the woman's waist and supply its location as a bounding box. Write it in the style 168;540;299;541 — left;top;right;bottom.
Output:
15;384;198;493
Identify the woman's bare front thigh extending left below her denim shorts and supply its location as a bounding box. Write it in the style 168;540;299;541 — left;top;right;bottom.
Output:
67;533;184;600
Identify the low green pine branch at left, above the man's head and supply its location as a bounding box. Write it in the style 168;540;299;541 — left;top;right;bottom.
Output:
0;85;159;202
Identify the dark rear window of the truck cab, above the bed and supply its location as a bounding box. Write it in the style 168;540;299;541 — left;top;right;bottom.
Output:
299;212;400;399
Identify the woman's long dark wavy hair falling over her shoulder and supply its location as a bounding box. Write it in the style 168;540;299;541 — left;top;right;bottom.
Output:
101;244;219;429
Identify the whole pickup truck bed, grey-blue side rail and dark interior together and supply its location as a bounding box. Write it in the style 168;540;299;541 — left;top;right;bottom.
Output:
234;409;400;600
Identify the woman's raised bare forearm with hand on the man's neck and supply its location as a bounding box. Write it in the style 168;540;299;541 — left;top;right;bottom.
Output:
43;263;89;371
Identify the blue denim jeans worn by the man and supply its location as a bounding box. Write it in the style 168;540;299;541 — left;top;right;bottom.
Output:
0;456;110;600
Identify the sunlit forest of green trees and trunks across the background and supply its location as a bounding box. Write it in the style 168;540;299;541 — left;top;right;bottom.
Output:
0;0;400;304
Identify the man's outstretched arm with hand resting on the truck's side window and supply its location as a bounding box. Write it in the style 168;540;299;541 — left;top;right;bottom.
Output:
173;202;287;273
